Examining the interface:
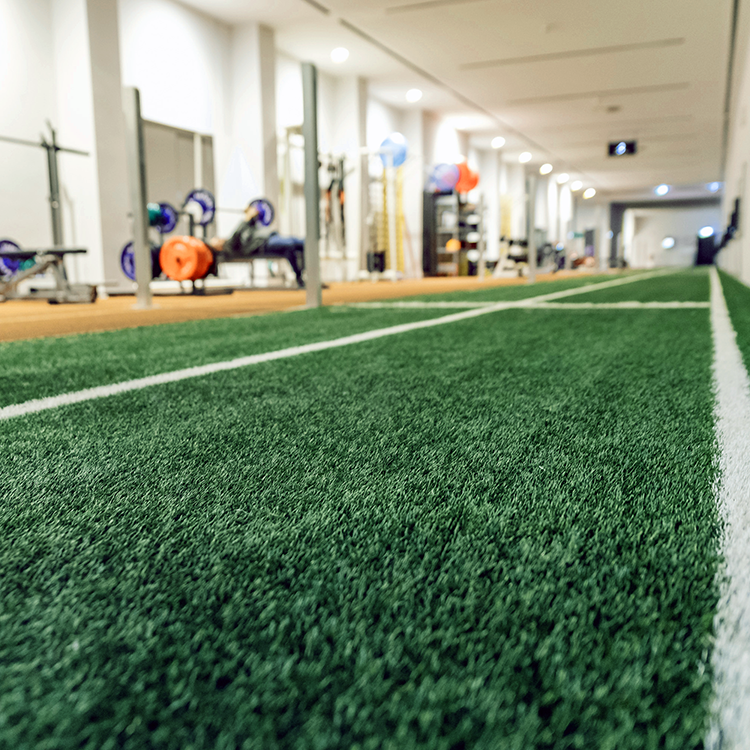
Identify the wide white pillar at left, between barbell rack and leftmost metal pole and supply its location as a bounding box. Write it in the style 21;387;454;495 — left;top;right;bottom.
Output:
52;0;131;286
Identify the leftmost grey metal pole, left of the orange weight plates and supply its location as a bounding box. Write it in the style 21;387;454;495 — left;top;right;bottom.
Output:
122;88;152;310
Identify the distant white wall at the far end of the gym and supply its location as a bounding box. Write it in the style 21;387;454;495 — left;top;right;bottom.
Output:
624;207;721;268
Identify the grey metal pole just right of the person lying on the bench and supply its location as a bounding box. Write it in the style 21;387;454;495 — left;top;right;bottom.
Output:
302;63;323;307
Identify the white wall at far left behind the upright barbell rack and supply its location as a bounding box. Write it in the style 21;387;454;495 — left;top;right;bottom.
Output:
0;0;58;247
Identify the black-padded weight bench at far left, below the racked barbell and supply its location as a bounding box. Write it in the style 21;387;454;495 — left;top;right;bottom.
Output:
0;247;96;305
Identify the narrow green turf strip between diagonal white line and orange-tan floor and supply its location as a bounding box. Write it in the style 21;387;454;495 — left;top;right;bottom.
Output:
0;276;656;406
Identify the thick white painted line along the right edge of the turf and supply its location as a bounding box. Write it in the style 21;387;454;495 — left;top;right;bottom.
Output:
706;268;750;750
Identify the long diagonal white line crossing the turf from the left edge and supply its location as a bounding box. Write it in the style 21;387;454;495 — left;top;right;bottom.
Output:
0;272;692;421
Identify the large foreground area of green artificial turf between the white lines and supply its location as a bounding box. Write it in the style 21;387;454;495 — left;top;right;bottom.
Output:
0;310;719;750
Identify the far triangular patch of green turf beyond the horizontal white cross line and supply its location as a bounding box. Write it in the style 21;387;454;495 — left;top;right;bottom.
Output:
560;268;709;302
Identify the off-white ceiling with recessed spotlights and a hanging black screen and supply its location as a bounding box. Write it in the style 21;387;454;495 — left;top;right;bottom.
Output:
176;0;733;197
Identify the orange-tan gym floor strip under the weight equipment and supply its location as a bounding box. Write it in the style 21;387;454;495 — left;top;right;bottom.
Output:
0;272;588;341
